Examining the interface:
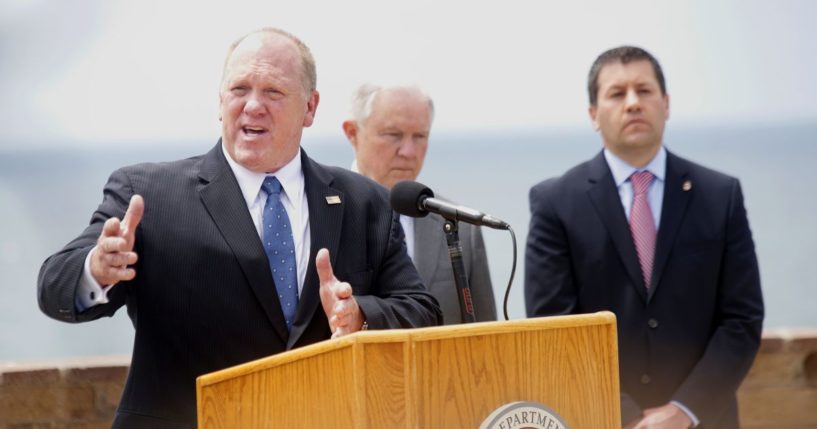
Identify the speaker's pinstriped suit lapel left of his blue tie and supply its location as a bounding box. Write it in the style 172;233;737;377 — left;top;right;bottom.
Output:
198;140;289;341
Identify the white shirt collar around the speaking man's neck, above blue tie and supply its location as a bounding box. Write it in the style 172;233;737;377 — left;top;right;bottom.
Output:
221;144;304;207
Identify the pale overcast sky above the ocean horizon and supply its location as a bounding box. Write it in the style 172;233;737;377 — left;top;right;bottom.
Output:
0;0;817;149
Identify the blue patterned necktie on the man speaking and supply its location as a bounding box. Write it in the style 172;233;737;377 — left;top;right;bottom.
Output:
261;176;298;331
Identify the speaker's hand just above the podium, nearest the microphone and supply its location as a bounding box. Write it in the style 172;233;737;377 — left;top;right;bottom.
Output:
315;249;363;338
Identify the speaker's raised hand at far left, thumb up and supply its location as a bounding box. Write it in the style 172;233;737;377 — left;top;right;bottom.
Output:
90;195;145;286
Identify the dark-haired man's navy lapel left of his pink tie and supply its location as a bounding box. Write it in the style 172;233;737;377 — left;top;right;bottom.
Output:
587;152;647;301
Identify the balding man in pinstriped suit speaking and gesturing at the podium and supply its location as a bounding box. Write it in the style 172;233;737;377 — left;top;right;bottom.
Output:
38;29;442;428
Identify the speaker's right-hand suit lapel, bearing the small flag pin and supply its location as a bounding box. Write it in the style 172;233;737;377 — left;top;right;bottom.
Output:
287;149;346;349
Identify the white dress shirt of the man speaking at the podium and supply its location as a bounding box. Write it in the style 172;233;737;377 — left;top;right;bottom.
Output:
74;145;311;311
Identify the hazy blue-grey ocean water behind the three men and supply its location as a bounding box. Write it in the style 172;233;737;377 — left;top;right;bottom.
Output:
0;123;817;361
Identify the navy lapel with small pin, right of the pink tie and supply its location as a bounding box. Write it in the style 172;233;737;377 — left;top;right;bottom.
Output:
650;151;693;296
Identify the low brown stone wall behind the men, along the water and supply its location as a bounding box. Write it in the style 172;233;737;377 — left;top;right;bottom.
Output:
0;328;817;429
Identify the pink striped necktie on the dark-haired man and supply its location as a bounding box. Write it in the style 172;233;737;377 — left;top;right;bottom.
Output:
630;171;655;289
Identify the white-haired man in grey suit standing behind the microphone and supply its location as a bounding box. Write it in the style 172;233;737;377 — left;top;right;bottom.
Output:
343;84;496;324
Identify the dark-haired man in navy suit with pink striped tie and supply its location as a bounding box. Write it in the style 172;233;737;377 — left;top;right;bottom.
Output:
525;46;763;429
